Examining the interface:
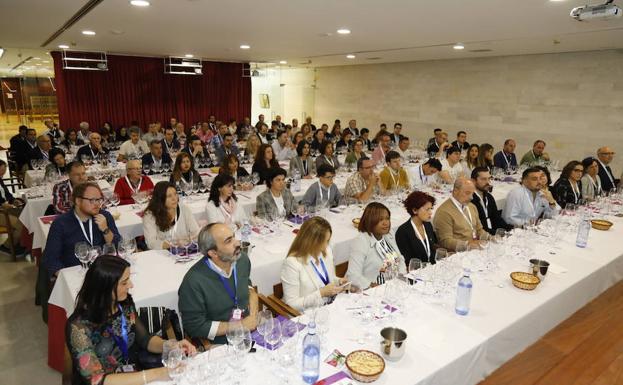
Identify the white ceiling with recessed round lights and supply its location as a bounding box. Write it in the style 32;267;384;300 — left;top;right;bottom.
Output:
0;0;623;71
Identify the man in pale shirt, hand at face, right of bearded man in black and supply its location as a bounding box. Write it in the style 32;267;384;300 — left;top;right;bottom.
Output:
502;167;559;226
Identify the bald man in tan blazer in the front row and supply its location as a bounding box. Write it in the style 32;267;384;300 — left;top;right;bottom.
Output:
433;178;489;251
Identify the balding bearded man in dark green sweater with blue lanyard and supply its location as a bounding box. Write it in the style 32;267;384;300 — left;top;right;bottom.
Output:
178;223;258;344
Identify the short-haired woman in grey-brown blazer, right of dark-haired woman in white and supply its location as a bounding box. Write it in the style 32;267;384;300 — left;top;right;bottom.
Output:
255;168;297;218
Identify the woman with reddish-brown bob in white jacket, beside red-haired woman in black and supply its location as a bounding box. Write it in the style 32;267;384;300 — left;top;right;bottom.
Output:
346;202;407;290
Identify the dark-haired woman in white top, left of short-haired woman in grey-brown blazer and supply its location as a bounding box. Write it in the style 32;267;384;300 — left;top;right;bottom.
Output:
206;174;249;231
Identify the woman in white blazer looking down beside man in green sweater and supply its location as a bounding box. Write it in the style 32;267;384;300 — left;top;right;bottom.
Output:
281;217;347;311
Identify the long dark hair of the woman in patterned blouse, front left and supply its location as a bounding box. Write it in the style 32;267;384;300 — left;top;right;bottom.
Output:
74;255;130;324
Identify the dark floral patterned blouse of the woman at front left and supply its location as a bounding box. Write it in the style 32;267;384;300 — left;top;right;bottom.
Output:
65;297;151;385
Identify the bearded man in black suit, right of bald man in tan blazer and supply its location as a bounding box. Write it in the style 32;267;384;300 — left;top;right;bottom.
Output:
472;167;513;235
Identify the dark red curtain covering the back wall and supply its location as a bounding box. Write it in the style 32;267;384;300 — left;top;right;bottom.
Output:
52;52;251;130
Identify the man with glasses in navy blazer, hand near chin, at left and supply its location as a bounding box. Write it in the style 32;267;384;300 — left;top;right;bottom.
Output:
43;182;121;280
